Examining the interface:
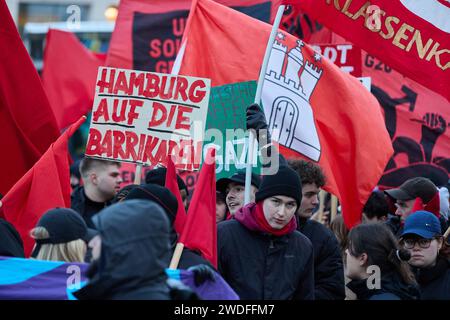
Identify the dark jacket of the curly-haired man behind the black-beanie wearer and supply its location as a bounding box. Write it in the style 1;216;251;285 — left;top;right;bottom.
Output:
297;217;345;300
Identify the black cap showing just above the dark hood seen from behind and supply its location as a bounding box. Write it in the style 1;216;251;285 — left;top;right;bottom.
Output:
125;183;178;225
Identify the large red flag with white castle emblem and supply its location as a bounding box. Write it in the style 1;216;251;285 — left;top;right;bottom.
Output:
180;0;393;227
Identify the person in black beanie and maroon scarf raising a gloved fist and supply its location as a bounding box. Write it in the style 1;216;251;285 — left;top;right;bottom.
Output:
217;107;314;300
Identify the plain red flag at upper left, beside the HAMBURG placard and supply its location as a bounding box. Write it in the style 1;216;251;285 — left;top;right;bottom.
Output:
42;30;106;129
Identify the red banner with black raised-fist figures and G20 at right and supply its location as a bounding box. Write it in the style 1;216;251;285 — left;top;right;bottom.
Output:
363;53;450;189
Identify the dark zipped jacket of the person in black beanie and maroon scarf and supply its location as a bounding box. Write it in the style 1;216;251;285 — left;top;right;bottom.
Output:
217;204;314;300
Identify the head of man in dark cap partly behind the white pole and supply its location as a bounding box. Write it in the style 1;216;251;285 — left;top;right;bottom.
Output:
216;170;261;219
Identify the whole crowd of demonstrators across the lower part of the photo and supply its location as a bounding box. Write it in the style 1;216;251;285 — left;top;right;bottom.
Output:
0;106;450;300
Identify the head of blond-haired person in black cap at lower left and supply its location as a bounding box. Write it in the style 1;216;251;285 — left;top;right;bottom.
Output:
30;208;96;262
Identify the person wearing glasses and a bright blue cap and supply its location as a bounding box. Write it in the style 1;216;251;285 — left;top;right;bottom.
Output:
400;211;450;300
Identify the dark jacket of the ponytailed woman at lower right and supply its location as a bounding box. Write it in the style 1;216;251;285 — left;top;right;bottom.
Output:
347;272;420;300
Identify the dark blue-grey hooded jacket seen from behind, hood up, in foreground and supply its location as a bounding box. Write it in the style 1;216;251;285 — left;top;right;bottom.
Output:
74;200;171;300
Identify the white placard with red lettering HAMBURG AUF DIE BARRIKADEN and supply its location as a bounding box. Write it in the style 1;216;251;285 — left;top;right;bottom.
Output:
86;67;210;170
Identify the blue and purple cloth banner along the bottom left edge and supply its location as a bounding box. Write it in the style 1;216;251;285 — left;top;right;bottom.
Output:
0;257;239;300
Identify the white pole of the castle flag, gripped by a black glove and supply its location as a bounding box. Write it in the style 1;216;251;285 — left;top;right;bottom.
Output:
244;5;286;204
